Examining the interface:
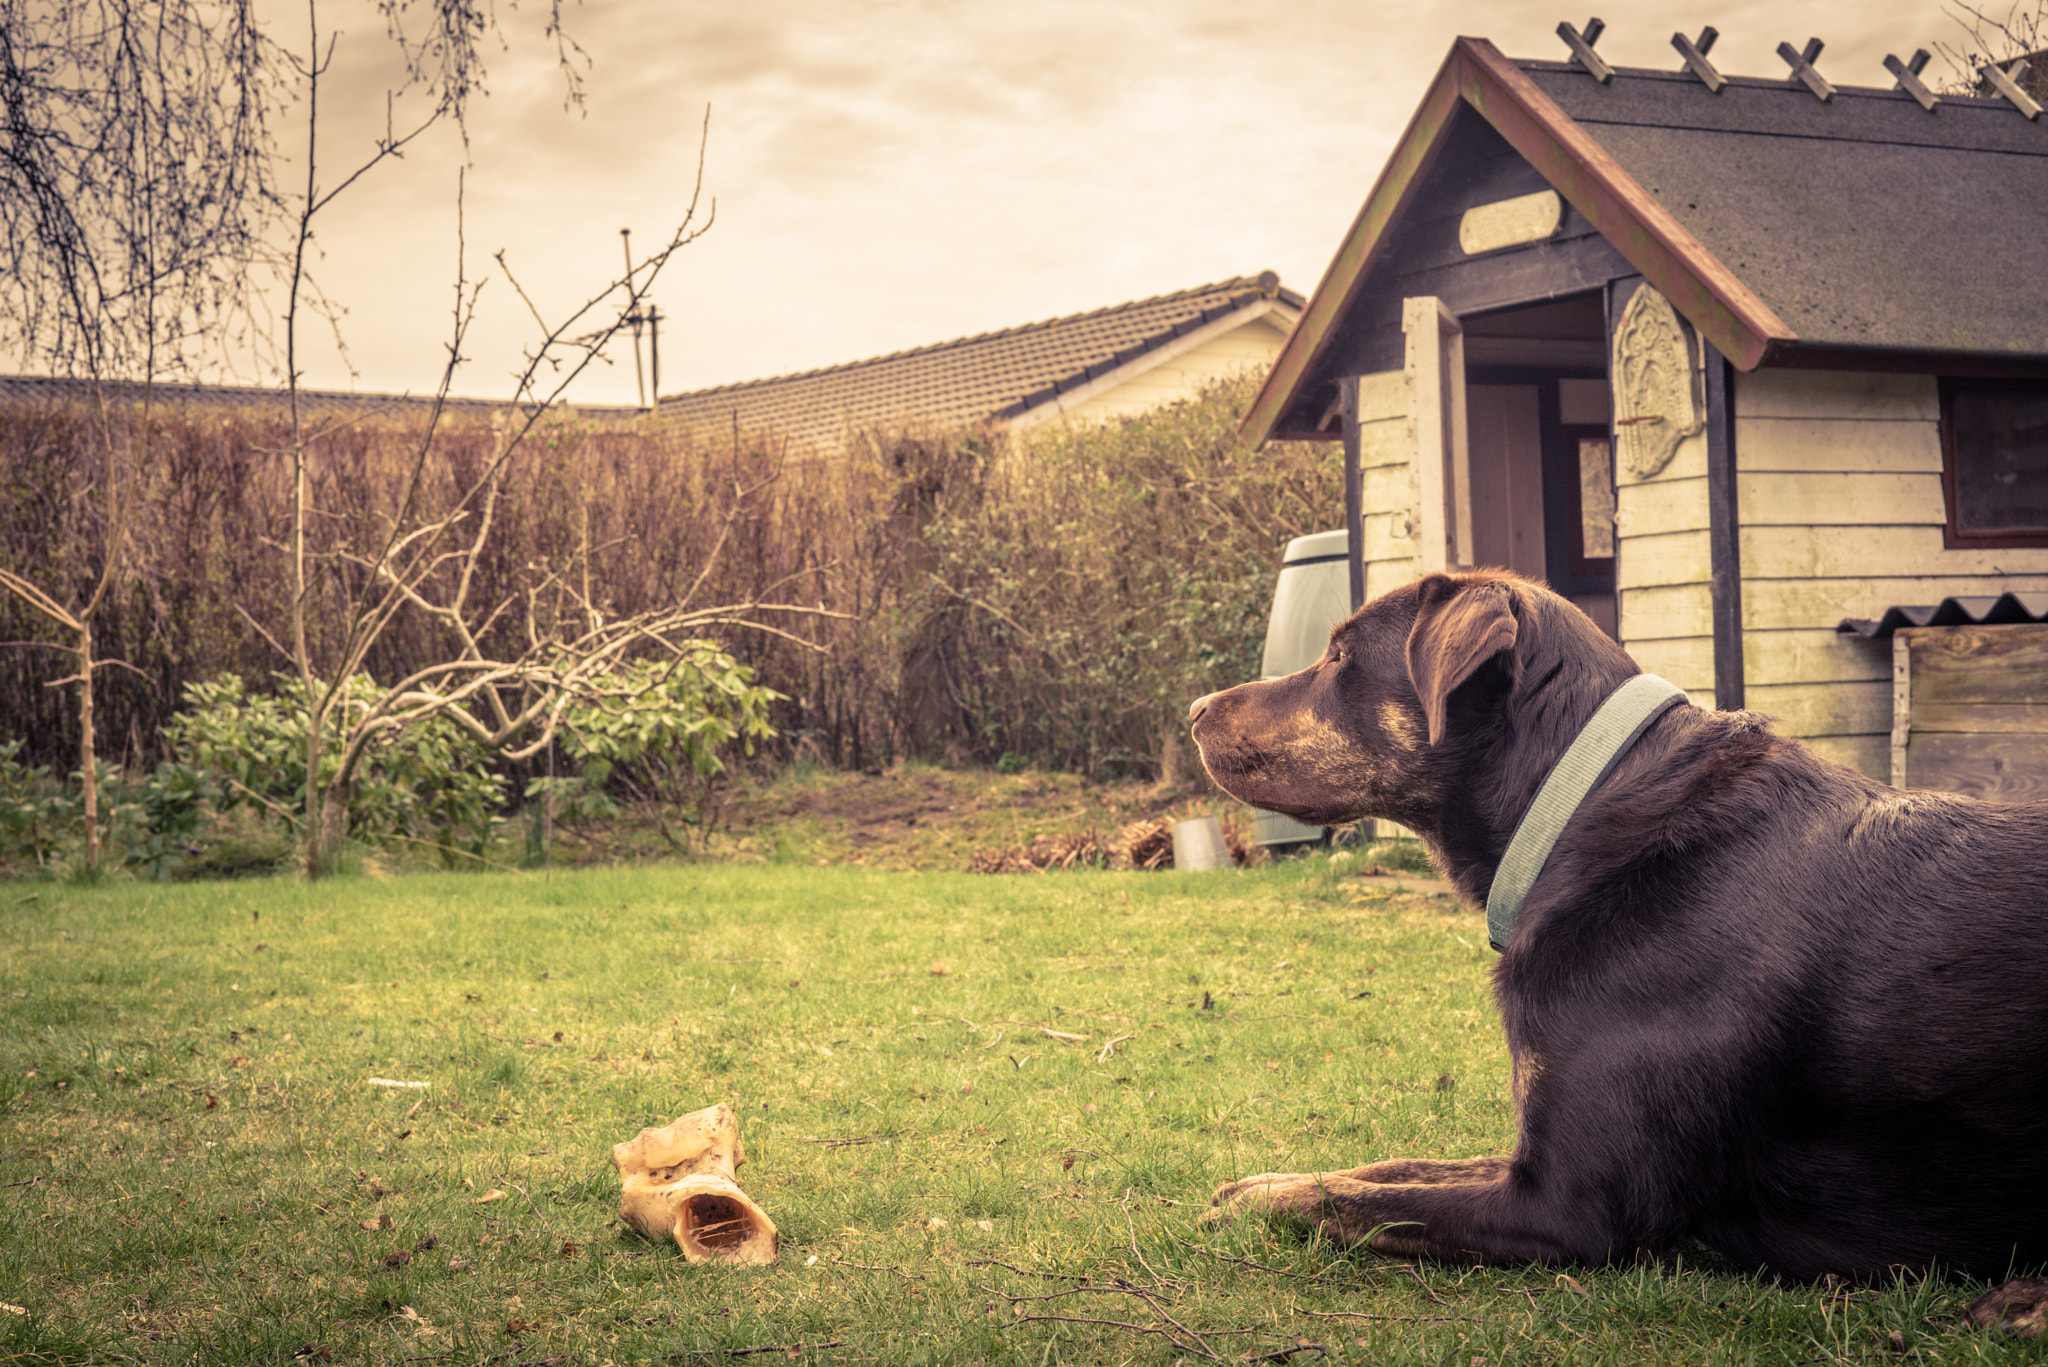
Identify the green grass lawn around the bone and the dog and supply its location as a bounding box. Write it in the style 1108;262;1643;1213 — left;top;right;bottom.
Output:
0;857;2044;1367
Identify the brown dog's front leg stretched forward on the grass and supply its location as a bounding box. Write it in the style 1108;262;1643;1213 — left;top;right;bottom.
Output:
1204;1158;1632;1262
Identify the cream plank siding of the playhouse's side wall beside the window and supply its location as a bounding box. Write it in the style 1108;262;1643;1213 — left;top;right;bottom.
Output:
1736;371;2048;779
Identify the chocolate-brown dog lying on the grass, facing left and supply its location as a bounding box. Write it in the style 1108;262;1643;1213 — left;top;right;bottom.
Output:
1188;570;2048;1322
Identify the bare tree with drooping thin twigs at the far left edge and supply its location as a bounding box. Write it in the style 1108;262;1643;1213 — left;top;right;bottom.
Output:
0;0;281;871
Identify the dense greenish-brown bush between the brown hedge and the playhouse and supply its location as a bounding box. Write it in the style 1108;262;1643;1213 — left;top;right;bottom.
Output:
899;381;1343;777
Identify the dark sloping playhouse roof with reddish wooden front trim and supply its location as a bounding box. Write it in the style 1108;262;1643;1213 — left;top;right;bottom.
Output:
1243;39;2048;441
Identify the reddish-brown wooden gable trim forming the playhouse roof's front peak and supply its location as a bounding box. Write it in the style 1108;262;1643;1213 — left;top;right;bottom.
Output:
1239;37;1798;445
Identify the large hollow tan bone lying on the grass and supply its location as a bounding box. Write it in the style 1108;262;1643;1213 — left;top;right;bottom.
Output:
612;1101;780;1262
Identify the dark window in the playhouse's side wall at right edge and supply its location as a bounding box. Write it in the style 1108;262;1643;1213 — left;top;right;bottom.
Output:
1942;379;2048;547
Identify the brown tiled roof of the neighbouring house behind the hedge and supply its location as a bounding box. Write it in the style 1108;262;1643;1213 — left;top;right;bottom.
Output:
662;271;1303;451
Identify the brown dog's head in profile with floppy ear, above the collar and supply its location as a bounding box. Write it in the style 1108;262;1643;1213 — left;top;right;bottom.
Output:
1188;570;1638;828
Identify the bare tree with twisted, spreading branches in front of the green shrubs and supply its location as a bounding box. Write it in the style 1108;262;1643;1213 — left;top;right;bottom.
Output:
279;0;817;877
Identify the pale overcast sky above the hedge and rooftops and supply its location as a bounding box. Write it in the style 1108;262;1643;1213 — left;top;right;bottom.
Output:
299;0;1962;404
